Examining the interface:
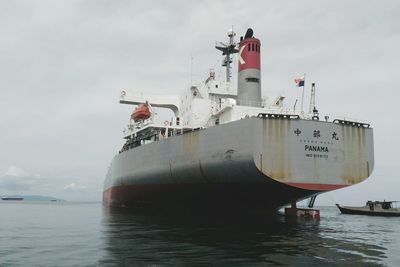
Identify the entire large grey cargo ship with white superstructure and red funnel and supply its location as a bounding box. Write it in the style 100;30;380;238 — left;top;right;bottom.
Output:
103;29;374;214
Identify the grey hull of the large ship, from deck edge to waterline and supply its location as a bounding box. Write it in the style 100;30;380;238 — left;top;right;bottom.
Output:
103;118;374;210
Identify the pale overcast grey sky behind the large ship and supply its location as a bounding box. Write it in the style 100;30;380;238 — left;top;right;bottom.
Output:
0;0;400;205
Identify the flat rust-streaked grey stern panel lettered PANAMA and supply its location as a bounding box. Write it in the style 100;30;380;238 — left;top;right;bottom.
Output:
257;118;374;188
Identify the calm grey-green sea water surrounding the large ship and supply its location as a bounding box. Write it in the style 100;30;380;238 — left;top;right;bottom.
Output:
0;201;400;266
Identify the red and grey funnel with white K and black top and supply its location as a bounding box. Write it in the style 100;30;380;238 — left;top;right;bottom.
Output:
237;29;262;107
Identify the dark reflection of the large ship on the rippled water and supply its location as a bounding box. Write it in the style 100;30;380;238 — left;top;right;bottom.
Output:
101;209;384;266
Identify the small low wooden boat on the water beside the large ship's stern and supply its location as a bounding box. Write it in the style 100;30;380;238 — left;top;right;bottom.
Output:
336;200;400;216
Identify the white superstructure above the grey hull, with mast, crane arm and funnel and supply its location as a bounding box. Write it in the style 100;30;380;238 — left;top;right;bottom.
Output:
120;30;315;136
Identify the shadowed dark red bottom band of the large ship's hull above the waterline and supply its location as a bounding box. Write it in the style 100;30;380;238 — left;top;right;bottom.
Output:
103;183;340;211
